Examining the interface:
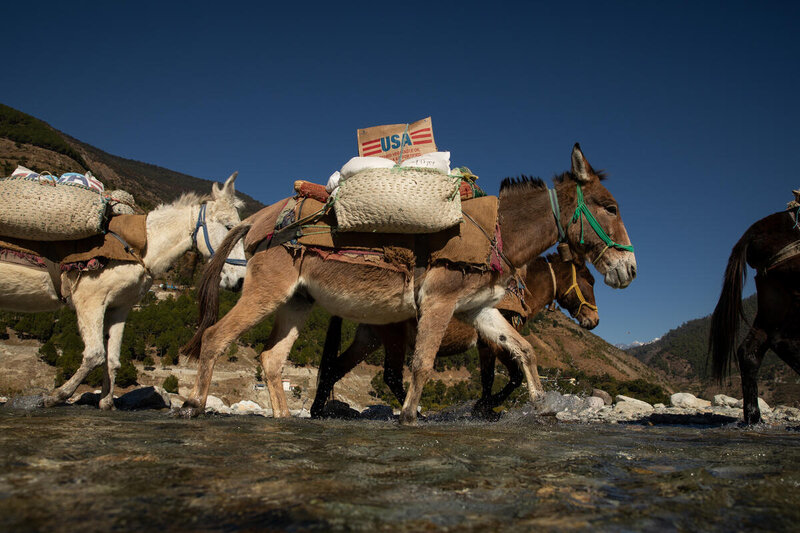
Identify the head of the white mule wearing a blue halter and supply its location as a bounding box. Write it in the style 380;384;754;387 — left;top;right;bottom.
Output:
196;172;245;289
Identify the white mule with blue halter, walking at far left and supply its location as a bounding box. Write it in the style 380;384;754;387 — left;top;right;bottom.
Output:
0;174;245;409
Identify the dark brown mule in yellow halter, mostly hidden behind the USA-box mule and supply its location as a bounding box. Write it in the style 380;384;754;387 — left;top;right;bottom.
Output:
311;254;600;418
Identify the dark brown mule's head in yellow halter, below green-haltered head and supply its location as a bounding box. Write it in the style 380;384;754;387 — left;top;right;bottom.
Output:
547;254;600;329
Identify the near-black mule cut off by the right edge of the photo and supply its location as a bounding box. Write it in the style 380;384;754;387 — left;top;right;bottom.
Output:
708;211;800;424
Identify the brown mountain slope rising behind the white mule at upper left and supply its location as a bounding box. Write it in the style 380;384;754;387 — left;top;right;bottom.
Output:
0;104;264;214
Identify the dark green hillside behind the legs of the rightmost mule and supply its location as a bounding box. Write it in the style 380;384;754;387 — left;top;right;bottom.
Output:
626;294;800;405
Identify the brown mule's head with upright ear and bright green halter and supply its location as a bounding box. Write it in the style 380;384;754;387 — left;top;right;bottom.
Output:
562;143;636;289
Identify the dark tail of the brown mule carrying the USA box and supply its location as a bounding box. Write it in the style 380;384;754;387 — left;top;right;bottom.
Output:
181;222;252;358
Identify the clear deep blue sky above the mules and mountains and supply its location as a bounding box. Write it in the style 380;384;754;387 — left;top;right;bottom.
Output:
0;1;800;343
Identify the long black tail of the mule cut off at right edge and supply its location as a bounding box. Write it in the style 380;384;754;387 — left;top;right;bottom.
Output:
708;230;750;381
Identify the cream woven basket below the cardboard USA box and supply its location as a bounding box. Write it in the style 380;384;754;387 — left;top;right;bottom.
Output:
334;167;461;233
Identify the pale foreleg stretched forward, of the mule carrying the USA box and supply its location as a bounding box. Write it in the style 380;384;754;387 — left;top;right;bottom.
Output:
473;308;544;401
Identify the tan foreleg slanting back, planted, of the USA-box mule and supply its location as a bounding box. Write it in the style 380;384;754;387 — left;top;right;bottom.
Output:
400;296;457;425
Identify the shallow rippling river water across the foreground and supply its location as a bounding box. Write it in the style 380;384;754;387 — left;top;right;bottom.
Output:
0;407;800;531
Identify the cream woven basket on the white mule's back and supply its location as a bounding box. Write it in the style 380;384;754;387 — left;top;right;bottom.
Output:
0;178;106;241
